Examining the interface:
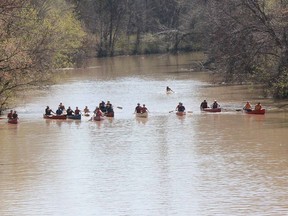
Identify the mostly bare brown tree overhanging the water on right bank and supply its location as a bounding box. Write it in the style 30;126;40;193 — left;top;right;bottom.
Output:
207;0;288;97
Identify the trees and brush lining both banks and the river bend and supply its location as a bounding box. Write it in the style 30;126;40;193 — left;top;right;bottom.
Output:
0;0;288;113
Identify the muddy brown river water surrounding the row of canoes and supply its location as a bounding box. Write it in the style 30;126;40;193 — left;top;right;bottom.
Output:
0;54;288;216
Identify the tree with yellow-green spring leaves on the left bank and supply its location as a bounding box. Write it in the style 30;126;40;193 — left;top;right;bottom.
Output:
0;0;85;111
